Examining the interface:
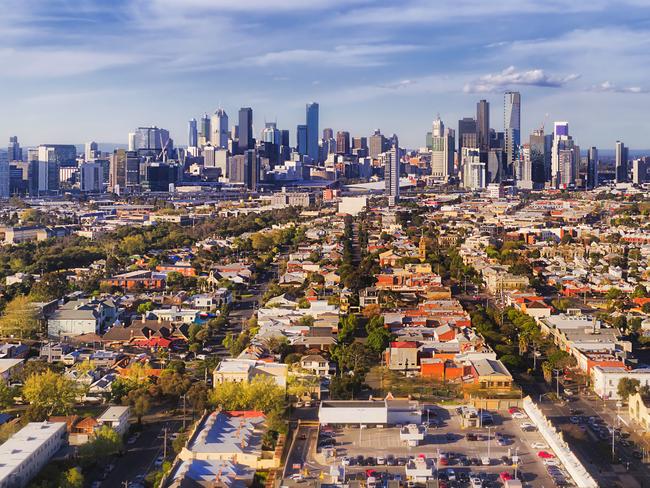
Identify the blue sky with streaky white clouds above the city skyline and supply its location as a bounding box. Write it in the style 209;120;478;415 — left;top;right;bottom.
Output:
0;0;650;148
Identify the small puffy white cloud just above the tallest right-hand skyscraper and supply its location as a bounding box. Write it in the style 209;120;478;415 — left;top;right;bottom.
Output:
463;66;580;93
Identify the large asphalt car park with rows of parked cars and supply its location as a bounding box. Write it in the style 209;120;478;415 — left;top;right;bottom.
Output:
318;407;572;488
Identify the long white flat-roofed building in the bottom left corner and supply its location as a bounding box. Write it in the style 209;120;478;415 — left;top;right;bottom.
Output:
0;422;67;488
